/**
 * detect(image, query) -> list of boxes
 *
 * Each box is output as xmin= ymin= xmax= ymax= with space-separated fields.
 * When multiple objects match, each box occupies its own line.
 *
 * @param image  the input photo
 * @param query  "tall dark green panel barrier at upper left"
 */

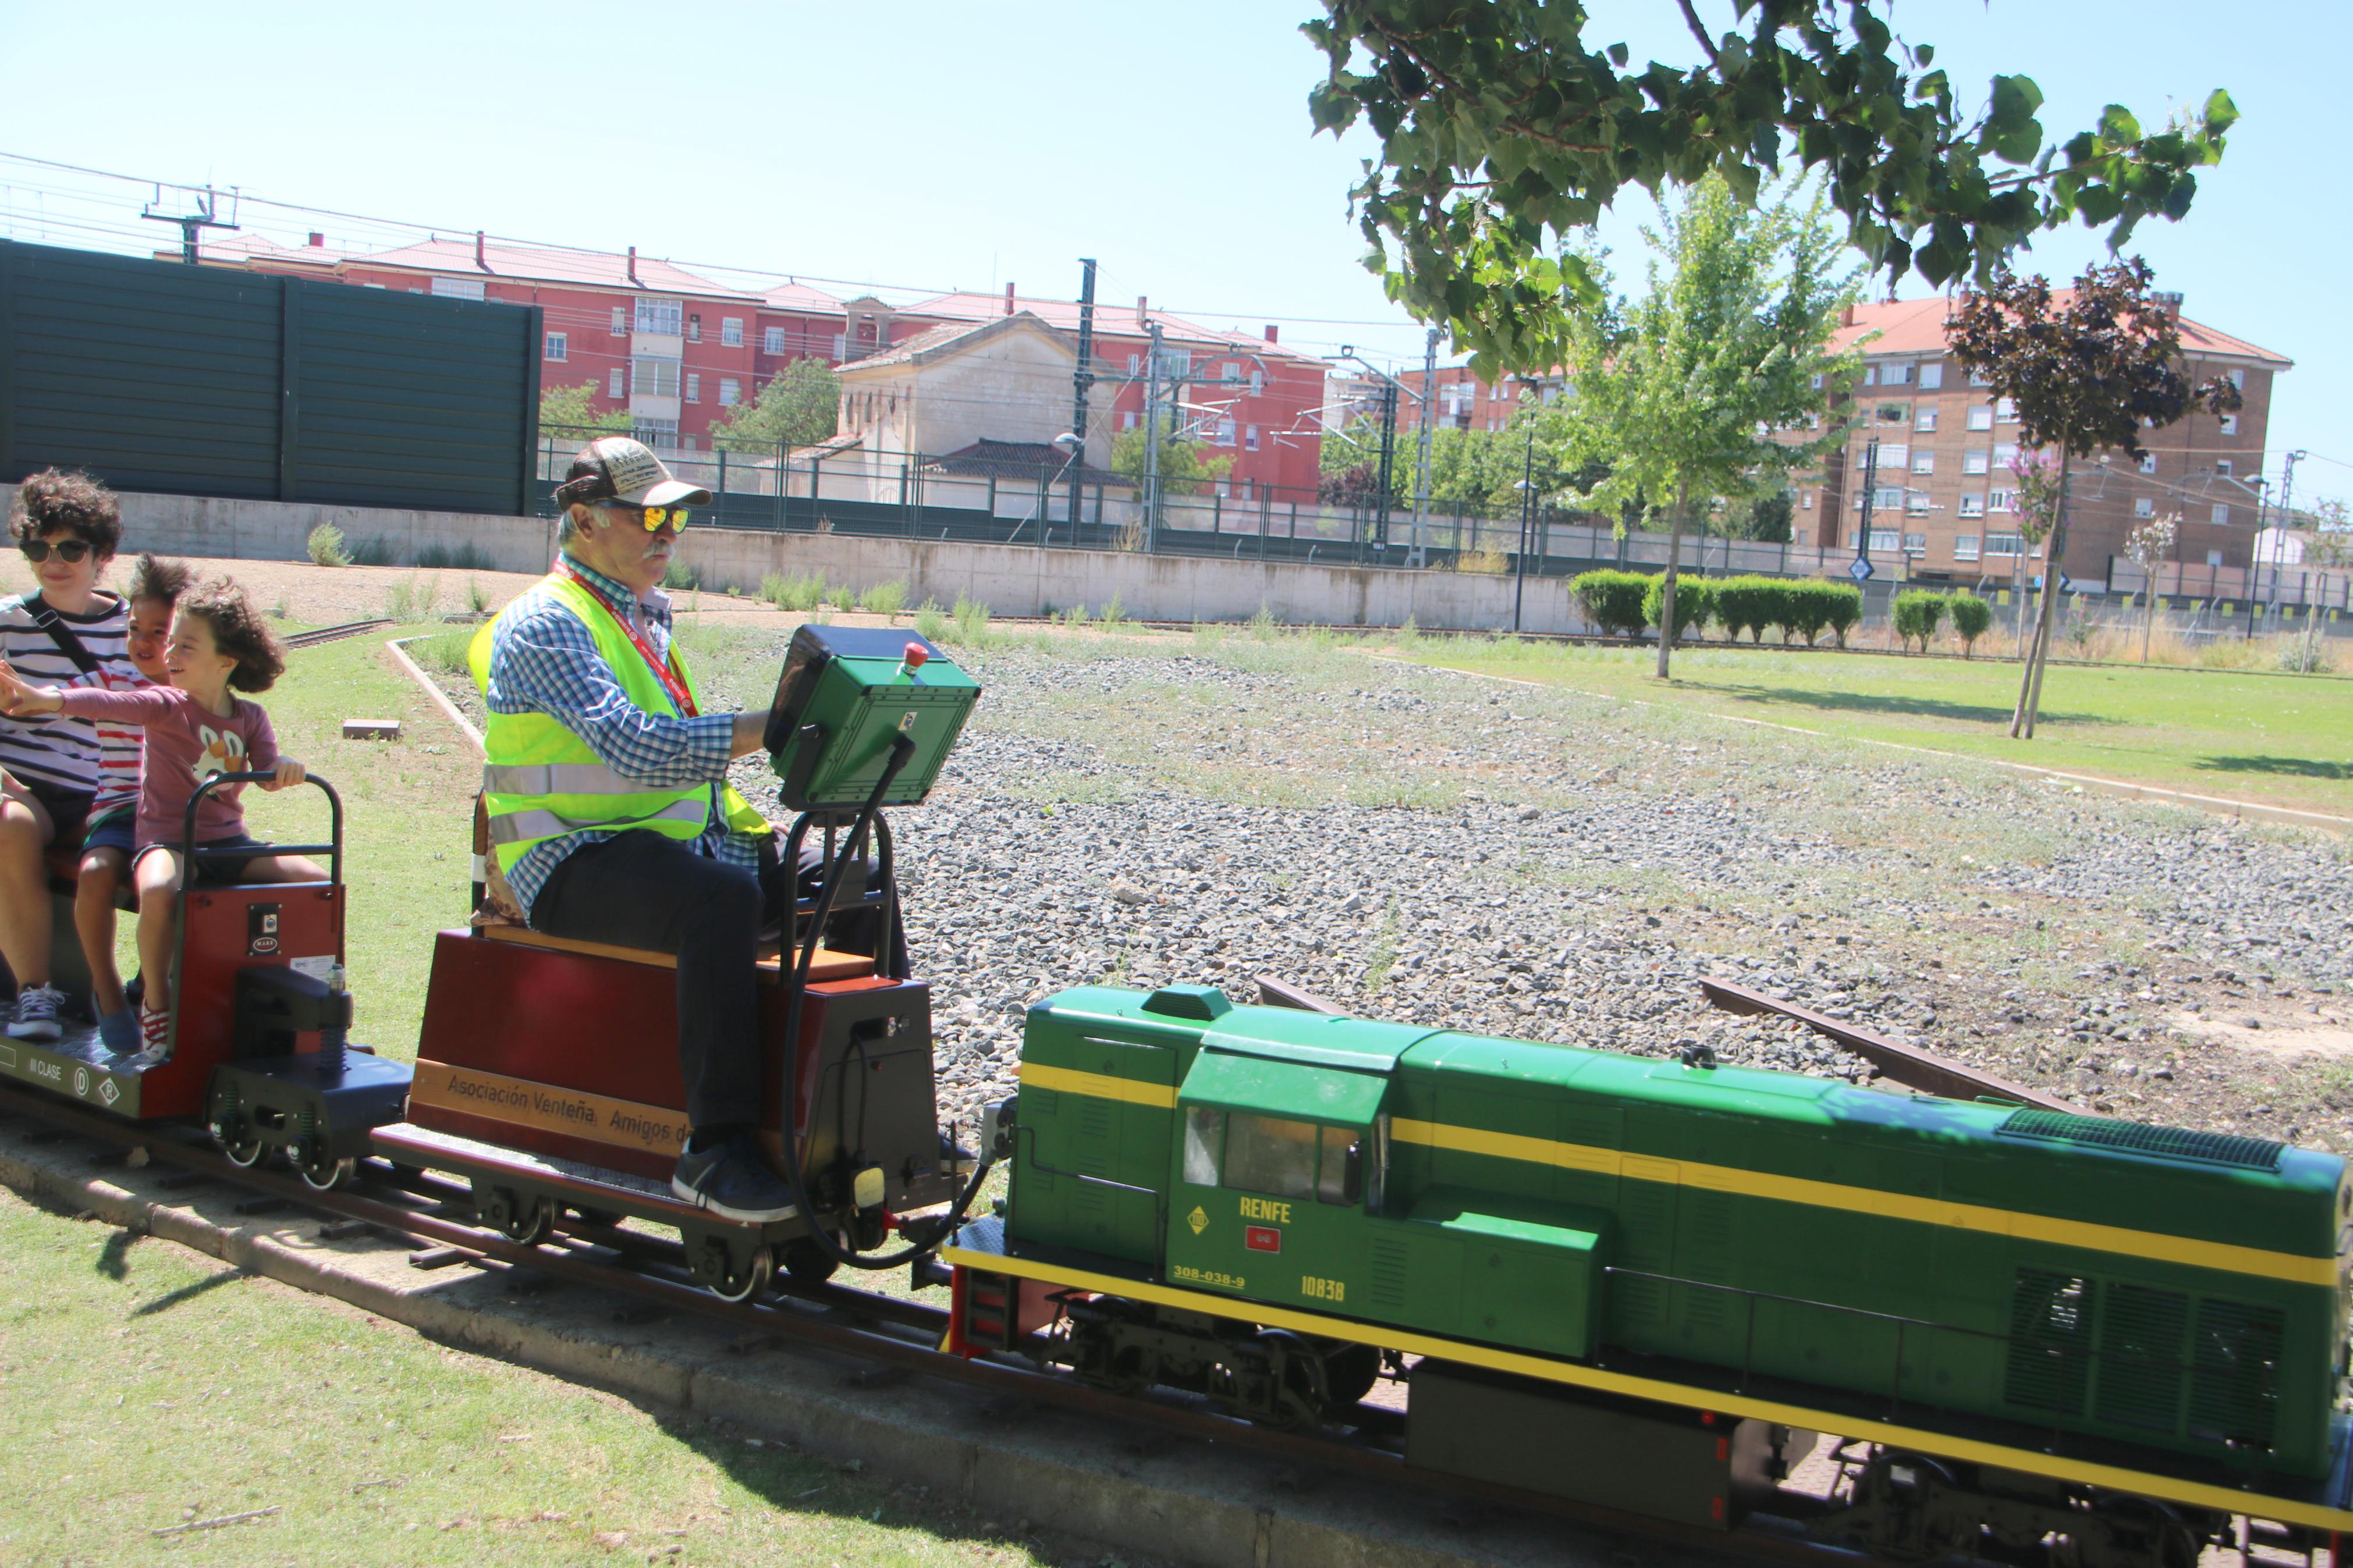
xmin=0 ymin=240 xmax=539 ymax=515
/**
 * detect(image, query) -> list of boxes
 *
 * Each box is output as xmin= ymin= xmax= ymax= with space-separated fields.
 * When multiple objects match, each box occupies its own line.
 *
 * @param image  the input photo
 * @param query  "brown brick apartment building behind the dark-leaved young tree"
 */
xmin=1791 ymin=296 xmax=2292 ymax=583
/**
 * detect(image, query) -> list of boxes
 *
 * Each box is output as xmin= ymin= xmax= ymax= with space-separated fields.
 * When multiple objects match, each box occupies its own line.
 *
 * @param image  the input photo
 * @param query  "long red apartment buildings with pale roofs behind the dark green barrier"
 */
xmin=174 ymin=235 xmax=1325 ymax=496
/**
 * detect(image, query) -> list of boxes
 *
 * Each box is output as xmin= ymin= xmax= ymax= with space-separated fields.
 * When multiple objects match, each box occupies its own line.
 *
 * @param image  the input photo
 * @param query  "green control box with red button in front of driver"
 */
xmin=765 ymin=625 xmax=981 ymax=811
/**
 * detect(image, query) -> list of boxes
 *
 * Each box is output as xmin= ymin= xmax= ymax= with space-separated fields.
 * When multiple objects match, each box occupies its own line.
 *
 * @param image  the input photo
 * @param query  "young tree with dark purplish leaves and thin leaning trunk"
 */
xmin=1946 ymin=256 xmax=2242 ymax=741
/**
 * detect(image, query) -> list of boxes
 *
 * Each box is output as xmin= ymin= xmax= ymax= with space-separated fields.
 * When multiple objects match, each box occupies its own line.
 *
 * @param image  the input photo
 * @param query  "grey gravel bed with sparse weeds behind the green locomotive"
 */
xmin=432 ymin=632 xmax=2353 ymax=1147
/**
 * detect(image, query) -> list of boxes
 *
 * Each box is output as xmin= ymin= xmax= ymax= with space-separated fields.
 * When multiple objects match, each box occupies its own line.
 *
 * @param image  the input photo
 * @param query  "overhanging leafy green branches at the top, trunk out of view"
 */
xmin=1301 ymin=0 xmax=2238 ymax=381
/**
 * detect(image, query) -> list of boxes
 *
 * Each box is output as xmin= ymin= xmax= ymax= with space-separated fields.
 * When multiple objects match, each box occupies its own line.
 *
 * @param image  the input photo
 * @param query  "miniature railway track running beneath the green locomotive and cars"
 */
xmin=0 ymin=1086 xmax=1871 ymax=1563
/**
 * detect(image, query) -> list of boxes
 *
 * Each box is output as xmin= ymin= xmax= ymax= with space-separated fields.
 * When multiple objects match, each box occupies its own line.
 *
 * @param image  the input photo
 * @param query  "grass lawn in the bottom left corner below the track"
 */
xmin=0 ymin=1192 xmax=1045 ymax=1568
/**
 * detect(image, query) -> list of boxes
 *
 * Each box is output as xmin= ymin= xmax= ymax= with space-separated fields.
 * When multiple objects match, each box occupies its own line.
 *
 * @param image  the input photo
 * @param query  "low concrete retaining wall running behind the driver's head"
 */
xmin=7 ymin=486 xmax=1591 ymax=632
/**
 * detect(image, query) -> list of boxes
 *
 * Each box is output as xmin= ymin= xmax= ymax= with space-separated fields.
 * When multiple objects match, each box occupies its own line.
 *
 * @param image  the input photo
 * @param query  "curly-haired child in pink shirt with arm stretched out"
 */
xmin=0 ymin=578 xmax=327 ymax=1065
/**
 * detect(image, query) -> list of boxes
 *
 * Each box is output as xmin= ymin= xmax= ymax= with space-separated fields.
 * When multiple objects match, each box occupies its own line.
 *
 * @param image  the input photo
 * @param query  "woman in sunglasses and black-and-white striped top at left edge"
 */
xmin=0 ymin=468 xmax=132 ymax=1041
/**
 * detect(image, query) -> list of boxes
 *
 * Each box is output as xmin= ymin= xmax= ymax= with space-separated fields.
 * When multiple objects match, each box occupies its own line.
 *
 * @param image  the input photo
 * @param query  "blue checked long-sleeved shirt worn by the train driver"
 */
xmin=482 ymin=557 xmax=760 ymax=919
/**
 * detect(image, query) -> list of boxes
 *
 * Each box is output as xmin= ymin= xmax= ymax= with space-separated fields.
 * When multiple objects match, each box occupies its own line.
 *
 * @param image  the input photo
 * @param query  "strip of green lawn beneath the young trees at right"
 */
xmin=1407 ymin=637 xmax=2353 ymax=816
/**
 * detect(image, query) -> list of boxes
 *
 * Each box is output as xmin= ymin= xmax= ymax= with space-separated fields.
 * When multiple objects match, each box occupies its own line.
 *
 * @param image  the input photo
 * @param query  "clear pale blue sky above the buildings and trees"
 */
xmin=0 ymin=0 xmax=2353 ymax=510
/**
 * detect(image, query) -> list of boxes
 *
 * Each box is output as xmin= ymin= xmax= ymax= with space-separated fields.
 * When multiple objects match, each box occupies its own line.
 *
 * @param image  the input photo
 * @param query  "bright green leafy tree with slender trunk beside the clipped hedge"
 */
xmin=1565 ymin=174 xmax=1861 ymax=680
